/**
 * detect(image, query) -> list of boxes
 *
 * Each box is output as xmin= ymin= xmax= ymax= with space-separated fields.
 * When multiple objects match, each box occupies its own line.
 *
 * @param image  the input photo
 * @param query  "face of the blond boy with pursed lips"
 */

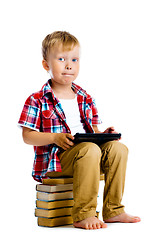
xmin=44 ymin=43 xmax=79 ymax=85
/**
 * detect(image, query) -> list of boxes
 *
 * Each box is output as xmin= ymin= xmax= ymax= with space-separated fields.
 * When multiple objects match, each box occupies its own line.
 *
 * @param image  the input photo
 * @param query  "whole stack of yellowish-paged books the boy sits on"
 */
xmin=35 ymin=178 xmax=73 ymax=227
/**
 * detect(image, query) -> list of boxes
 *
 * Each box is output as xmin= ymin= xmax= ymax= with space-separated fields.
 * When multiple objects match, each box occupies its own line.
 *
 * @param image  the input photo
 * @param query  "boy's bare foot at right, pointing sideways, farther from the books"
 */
xmin=104 ymin=213 xmax=141 ymax=223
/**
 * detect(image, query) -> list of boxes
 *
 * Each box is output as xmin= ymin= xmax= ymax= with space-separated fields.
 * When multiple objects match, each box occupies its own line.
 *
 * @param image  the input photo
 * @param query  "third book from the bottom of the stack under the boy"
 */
xmin=36 ymin=199 xmax=74 ymax=209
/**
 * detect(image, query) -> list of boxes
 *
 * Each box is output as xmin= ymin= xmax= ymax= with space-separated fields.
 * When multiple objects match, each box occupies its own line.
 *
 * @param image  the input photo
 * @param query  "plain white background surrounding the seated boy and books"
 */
xmin=0 ymin=0 xmax=160 ymax=239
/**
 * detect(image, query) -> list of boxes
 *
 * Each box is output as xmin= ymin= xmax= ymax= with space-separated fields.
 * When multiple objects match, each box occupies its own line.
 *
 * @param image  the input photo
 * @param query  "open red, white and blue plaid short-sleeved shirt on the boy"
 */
xmin=18 ymin=80 xmax=101 ymax=182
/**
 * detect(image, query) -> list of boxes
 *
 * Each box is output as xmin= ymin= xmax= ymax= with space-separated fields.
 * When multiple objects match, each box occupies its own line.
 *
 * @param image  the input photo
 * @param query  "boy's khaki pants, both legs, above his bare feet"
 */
xmin=47 ymin=141 xmax=128 ymax=222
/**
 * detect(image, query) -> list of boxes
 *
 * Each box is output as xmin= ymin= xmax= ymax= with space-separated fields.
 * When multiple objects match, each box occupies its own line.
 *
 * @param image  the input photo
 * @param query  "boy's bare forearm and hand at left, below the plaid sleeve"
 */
xmin=22 ymin=127 xmax=74 ymax=150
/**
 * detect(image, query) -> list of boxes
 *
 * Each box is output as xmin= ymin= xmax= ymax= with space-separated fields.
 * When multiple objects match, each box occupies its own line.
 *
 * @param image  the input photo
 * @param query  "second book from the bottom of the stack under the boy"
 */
xmin=35 ymin=207 xmax=72 ymax=218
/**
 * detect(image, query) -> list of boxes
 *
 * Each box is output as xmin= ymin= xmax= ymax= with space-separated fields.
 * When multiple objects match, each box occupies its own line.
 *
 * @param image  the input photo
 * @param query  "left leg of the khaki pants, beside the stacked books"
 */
xmin=47 ymin=142 xmax=101 ymax=222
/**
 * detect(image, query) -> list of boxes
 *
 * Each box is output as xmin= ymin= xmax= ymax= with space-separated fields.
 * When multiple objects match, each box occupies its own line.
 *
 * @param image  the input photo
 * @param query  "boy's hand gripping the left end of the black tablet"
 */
xmin=54 ymin=133 xmax=74 ymax=150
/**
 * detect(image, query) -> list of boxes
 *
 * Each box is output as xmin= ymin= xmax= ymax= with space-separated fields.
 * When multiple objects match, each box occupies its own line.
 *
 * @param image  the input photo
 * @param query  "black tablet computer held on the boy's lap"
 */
xmin=73 ymin=133 xmax=121 ymax=144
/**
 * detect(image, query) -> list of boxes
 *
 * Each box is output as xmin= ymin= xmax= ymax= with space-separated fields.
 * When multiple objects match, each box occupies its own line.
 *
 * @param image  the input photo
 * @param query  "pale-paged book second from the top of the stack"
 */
xmin=36 ymin=184 xmax=73 ymax=192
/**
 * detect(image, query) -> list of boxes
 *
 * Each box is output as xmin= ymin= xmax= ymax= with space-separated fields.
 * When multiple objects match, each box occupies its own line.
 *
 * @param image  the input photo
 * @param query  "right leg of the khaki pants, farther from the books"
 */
xmin=100 ymin=141 xmax=128 ymax=220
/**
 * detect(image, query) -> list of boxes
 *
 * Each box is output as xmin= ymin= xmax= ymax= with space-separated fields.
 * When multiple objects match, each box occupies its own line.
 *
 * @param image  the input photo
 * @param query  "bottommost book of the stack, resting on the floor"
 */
xmin=38 ymin=216 xmax=73 ymax=227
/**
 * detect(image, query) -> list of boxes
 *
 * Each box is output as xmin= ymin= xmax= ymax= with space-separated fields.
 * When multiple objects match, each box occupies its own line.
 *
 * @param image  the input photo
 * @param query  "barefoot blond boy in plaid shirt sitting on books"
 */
xmin=19 ymin=31 xmax=140 ymax=229
